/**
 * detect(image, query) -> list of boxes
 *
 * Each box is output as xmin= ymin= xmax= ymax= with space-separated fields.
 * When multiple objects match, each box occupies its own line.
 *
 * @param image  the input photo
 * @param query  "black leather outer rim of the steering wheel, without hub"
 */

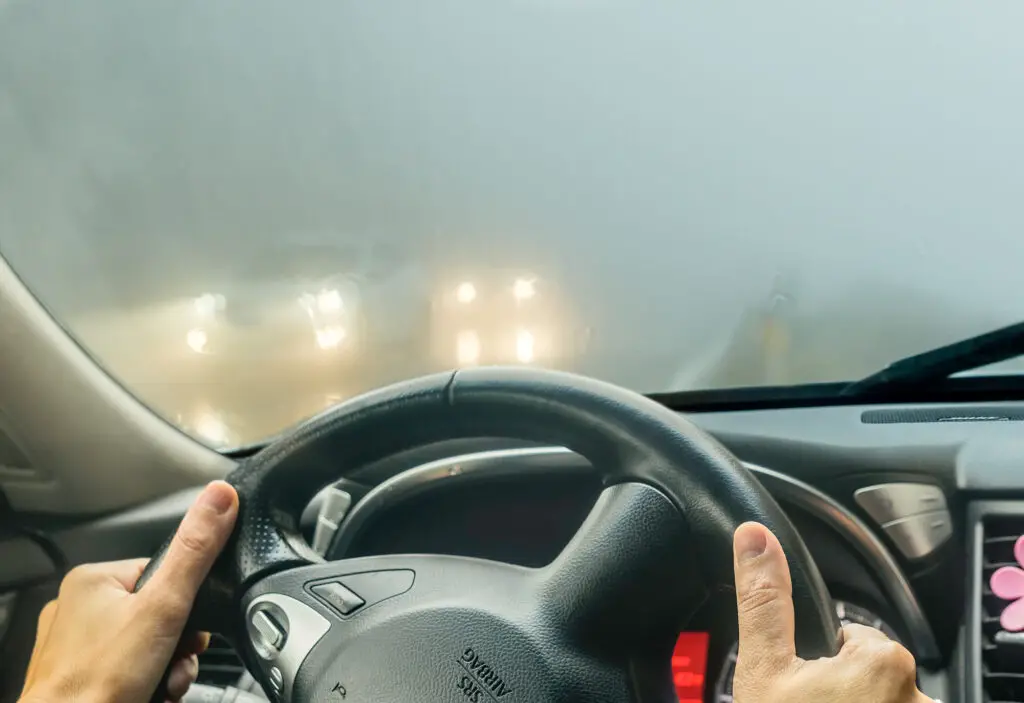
xmin=138 ymin=368 xmax=839 ymax=657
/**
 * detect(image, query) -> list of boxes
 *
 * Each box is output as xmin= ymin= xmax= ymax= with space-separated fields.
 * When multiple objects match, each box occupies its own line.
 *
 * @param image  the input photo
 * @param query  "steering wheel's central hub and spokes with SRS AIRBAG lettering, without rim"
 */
xmin=243 ymin=483 xmax=695 ymax=701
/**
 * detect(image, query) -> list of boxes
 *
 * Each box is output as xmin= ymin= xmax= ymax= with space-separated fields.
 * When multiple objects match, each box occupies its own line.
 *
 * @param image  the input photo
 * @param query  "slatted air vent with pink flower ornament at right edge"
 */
xmin=981 ymin=517 xmax=1024 ymax=703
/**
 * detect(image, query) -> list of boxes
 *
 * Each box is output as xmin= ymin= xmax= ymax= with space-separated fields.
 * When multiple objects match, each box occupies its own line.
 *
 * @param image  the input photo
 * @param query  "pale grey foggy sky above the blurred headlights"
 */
xmin=0 ymin=0 xmax=1024 ymax=374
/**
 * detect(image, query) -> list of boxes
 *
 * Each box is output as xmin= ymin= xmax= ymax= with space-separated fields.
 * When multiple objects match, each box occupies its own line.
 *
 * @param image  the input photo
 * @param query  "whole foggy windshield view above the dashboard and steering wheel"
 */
xmin=0 ymin=0 xmax=1024 ymax=446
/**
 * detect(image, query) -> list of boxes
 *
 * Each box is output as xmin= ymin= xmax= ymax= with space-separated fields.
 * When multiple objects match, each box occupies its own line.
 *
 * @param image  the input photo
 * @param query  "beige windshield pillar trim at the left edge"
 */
xmin=0 ymin=256 xmax=233 ymax=514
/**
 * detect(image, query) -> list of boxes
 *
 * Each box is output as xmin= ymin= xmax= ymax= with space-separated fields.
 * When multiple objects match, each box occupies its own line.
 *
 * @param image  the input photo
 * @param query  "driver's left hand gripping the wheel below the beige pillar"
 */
xmin=19 ymin=481 xmax=239 ymax=703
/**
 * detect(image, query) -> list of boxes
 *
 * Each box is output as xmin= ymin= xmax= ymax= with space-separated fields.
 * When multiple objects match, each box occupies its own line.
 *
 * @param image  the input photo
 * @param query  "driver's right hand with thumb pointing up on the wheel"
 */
xmin=732 ymin=523 xmax=933 ymax=703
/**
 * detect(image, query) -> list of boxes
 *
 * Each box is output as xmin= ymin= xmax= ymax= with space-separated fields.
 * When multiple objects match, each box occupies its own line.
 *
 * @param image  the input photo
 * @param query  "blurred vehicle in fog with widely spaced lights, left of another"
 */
xmin=184 ymin=235 xmax=430 ymax=374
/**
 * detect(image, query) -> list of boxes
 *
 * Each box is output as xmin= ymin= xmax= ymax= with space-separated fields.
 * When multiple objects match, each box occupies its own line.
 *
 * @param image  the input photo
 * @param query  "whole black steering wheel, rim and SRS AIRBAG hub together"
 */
xmin=137 ymin=368 xmax=840 ymax=703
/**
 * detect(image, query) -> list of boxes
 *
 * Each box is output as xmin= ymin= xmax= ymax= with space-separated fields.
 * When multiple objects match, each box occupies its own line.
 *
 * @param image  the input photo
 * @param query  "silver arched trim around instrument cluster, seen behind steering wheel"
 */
xmin=329 ymin=446 xmax=940 ymax=663
